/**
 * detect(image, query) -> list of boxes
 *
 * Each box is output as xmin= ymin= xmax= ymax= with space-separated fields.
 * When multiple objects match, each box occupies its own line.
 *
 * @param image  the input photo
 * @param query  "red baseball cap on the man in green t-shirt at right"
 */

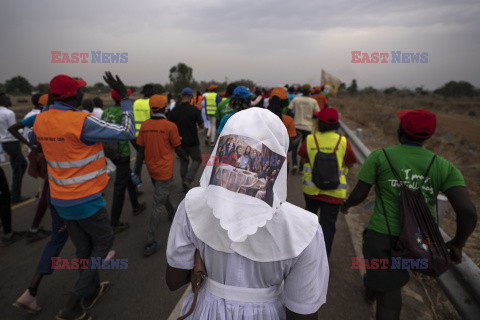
xmin=397 ymin=109 xmax=437 ymax=138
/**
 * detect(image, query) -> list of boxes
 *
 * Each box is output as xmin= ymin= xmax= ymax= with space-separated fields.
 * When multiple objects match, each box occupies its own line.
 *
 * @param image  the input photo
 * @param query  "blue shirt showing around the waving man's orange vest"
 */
xmin=30 ymin=100 xmax=135 ymax=220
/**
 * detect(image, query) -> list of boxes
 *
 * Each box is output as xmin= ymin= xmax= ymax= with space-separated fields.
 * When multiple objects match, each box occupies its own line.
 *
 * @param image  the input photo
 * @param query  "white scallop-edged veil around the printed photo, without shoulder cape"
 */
xmin=200 ymin=108 xmax=289 ymax=242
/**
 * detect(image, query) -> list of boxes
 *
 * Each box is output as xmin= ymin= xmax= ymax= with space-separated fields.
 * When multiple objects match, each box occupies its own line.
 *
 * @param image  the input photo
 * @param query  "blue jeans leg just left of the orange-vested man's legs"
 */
xmin=36 ymin=187 xmax=68 ymax=274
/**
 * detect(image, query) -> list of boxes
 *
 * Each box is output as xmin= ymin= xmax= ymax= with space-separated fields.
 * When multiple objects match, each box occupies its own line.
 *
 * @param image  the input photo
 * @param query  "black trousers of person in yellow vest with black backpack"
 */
xmin=303 ymin=194 xmax=341 ymax=257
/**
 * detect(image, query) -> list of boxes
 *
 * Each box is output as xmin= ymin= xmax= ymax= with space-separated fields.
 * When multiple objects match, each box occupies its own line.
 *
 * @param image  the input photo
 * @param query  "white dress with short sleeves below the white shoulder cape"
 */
xmin=167 ymin=200 xmax=329 ymax=320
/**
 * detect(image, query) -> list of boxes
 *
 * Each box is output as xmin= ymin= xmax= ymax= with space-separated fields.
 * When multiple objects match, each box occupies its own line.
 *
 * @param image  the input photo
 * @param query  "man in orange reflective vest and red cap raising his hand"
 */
xmin=31 ymin=72 xmax=135 ymax=320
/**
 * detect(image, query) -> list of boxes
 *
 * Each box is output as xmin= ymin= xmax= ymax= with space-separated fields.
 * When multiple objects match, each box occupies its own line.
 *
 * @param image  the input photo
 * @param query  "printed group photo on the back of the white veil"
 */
xmin=210 ymin=134 xmax=285 ymax=206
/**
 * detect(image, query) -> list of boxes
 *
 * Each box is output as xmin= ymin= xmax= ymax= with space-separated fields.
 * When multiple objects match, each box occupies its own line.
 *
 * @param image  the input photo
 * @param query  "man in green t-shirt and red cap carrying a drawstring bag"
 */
xmin=341 ymin=110 xmax=477 ymax=319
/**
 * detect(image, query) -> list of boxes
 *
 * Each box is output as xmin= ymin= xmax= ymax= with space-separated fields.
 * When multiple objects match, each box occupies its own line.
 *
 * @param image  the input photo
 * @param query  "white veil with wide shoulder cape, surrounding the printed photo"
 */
xmin=185 ymin=108 xmax=319 ymax=262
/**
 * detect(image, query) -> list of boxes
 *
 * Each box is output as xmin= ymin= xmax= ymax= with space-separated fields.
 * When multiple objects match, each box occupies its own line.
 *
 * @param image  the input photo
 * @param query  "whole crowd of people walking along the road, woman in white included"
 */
xmin=0 ymin=72 xmax=476 ymax=320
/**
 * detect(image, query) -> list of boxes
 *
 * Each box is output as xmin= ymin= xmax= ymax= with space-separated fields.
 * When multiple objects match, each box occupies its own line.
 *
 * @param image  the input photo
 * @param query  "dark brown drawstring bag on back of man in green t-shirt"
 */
xmin=377 ymin=149 xmax=451 ymax=277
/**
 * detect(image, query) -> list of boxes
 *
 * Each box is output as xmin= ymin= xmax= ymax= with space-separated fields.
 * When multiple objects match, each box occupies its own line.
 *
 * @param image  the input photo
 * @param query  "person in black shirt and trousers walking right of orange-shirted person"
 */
xmin=168 ymin=88 xmax=203 ymax=192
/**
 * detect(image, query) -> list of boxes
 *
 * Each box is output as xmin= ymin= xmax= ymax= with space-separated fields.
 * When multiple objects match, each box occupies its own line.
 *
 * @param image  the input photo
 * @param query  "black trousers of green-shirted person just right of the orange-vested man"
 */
xmin=111 ymin=157 xmax=140 ymax=226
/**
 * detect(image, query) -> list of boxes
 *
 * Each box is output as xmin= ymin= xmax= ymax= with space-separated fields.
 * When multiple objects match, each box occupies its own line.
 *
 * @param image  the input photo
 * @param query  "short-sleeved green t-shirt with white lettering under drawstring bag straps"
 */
xmin=357 ymin=145 xmax=465 ymax=236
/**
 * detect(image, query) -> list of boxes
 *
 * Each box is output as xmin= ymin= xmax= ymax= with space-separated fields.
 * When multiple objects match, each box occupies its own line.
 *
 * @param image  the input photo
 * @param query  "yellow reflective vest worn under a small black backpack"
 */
xmin=302 ymin=131 xmax=348 ymax=199
